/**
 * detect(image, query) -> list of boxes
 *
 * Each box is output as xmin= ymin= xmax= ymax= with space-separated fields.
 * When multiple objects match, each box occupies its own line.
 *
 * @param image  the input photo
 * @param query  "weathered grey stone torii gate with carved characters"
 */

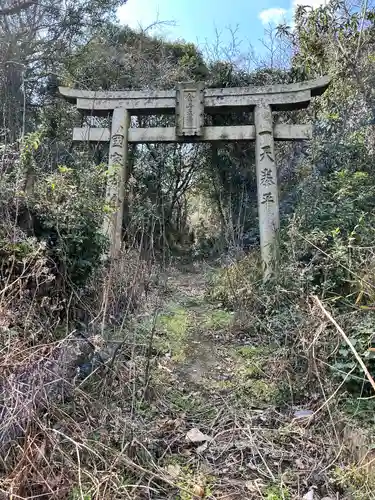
xmin=59 ymin=77 xmax=329 ymax=279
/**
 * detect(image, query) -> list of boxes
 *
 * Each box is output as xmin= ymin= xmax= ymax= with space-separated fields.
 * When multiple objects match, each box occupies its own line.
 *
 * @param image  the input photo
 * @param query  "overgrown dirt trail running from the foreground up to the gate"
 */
xmin=132 ymin=266 xmax=338 ymax=500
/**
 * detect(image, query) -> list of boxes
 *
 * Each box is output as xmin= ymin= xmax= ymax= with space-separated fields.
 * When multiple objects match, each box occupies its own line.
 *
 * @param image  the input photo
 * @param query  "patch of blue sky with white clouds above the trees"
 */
xmin=118 ymin=0 xmax=324 ymax=56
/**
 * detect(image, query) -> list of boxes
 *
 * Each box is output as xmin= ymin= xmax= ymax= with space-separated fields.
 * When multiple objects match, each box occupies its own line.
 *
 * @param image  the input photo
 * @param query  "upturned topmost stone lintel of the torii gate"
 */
xmin=59 ymin=76 xmax=330 ymax=115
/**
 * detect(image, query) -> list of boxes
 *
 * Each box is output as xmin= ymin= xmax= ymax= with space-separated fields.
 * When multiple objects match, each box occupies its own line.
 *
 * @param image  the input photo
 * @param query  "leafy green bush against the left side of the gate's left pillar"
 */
xmin=29 ymin=165 xmax=105 ymax=285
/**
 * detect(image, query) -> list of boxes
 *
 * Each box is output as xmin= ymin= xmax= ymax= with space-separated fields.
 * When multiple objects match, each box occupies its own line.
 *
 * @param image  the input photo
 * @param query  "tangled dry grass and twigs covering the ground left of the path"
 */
xmin=0 ymin=238 xmax=162 ymax=498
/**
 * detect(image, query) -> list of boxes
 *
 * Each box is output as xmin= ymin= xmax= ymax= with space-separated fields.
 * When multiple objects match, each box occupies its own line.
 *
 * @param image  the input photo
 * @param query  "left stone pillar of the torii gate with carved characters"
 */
xmin=103 ymin=108 xmax=130 ymax=259
